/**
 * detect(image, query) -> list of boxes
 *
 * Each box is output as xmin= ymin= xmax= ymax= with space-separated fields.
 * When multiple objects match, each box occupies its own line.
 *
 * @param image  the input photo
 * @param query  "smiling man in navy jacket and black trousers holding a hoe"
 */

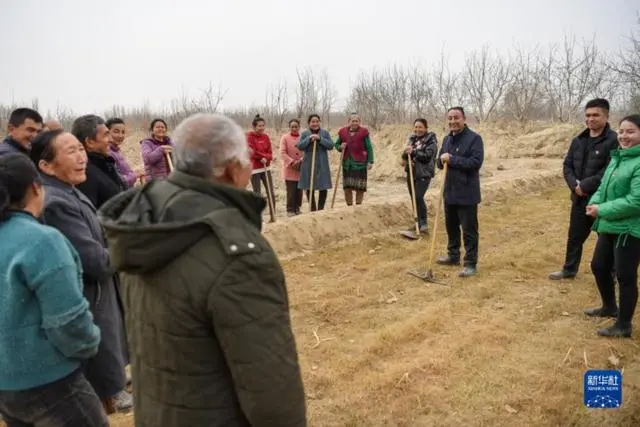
xmin=436 ymin=107 xmax=484 ymax=277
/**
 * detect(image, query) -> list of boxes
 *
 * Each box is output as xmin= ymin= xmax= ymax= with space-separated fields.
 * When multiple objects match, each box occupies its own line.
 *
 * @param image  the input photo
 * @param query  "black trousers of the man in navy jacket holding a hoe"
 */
xmin=444 ymin=203 xmax=479 ymax=267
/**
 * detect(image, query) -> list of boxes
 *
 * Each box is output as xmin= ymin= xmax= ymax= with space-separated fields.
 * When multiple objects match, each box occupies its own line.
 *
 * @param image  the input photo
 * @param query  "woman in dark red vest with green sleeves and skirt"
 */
xmin=336 ymin=114 xmax=373 ymax=206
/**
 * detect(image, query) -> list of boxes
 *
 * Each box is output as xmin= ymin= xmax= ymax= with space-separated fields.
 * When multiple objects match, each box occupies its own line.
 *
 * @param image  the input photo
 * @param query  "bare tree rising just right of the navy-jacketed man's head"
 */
xmin=462 ymin=45 xmax=511 ymax=121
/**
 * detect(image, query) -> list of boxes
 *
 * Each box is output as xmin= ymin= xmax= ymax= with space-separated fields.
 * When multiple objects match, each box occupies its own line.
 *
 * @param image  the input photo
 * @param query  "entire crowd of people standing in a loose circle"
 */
xmin=0 ymin=99 xmax=640 ymax=427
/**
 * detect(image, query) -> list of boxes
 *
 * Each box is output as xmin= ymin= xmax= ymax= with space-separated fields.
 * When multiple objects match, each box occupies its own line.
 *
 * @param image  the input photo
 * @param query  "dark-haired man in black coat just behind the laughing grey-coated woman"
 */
xmin=71 ymin=114 xmax=126 ymax=209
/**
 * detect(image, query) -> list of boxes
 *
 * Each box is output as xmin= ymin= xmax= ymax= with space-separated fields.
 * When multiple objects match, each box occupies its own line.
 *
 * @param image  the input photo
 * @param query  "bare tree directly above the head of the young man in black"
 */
xmin=543 ymin=35 xmax=613 ymax=122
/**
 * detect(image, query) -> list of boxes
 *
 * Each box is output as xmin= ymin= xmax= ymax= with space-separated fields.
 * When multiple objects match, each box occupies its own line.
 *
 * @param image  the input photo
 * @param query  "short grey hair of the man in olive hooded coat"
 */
xmin=171 ymin=113 xmax=250 ymax=179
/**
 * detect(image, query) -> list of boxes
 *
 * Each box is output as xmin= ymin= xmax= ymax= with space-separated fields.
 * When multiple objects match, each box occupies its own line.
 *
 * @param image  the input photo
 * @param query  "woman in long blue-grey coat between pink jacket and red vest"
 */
xmin=297 ymin=114 xmax=334 ymax=211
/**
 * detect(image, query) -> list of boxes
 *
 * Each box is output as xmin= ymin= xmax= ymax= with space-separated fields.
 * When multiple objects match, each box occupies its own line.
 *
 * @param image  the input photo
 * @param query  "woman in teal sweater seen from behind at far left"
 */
xmin=0 ymin=153 xmax=109 ymax=427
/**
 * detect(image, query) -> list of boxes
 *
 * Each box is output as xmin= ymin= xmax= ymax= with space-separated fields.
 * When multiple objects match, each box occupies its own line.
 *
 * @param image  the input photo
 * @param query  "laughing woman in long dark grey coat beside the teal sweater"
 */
xmin=31 ymin=130 xmax=127 ymax=413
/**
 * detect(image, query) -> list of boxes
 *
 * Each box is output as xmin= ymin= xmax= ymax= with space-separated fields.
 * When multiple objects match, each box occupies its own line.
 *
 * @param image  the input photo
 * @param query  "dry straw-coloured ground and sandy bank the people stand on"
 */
xmin=6 ymin=125 xmax=640 ymax=427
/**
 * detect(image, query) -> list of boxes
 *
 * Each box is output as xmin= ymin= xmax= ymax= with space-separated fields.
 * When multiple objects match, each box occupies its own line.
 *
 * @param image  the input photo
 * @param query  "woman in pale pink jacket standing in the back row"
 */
xmin=280 ymin=119 xmax=302 ymax=216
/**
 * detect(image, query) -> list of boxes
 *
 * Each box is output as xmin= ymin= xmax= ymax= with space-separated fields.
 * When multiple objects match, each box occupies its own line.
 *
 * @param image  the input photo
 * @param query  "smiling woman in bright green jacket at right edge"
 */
xmin=584 ymin=114 xmax=640 ymax=338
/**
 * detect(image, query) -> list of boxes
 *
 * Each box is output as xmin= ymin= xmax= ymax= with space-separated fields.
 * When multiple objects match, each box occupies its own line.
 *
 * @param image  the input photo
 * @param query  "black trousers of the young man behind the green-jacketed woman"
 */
xmin=562 ymin=197 xmax=594 ymax=275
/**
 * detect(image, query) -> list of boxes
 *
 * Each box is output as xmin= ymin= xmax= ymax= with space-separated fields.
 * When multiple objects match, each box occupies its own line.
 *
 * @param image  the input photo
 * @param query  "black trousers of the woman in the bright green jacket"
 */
xmin=591 ymin=234 xmax=640 ymax=326
